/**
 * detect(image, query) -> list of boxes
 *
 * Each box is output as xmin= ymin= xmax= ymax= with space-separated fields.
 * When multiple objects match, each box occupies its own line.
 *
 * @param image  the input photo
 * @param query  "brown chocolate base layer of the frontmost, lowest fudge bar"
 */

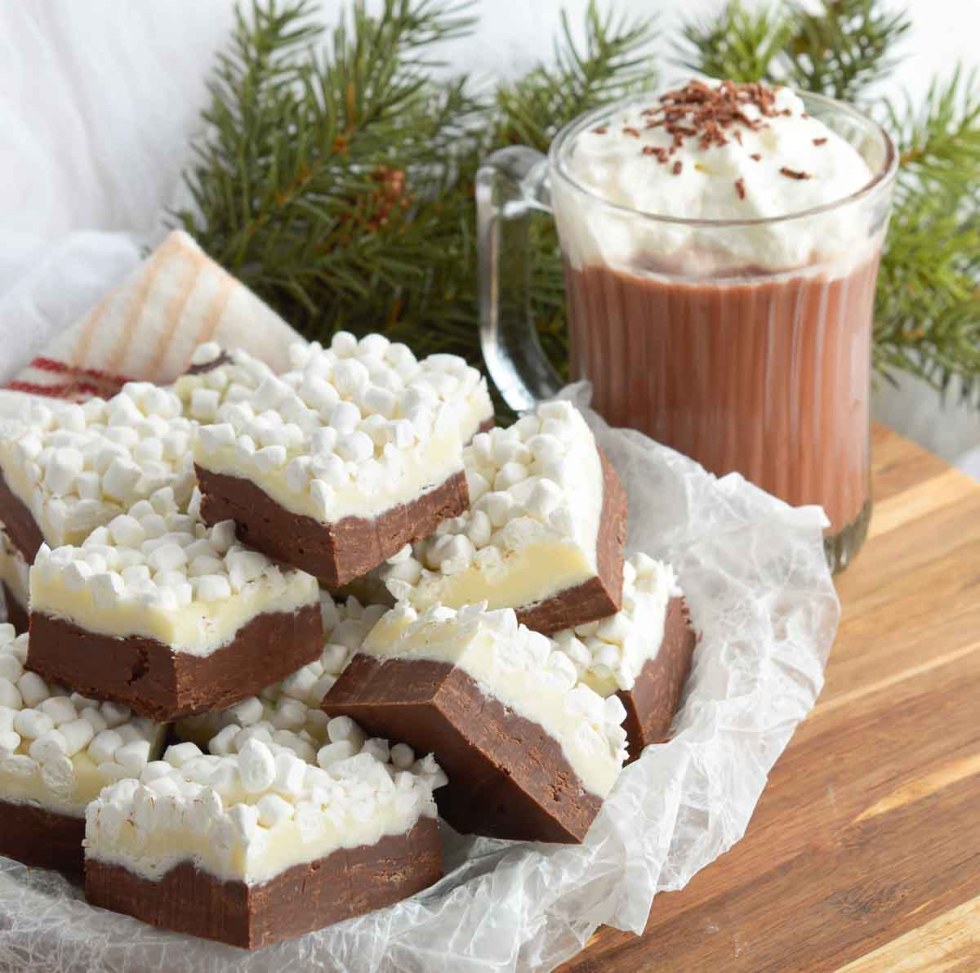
xmin=85 ymin=818 xmax=442 ymax=949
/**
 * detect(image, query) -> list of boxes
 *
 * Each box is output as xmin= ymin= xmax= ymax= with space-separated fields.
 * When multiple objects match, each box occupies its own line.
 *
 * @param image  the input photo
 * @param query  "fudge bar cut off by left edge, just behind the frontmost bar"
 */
xmin=0 ymin=625 xmax=164 ymax=872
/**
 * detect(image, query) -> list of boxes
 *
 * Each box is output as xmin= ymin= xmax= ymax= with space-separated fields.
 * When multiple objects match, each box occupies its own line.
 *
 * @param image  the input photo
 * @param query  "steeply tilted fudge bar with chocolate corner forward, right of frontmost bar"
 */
xmin=323 ymin=604 xmax=626 ymax=842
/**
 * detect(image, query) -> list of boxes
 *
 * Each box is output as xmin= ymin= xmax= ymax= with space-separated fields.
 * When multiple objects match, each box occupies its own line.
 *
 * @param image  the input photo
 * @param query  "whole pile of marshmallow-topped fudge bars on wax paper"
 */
xmin=0 ymin=333 xmax=695 ymax=948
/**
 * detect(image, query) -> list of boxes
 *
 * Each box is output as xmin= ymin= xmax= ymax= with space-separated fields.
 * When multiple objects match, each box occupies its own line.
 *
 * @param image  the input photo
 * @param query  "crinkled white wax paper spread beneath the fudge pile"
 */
xmin=0 ymin=387 xmax=839 ymax=973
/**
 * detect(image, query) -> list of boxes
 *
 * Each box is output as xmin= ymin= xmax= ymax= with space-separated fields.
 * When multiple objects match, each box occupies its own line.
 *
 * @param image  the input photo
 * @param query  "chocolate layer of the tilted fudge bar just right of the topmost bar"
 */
xmin=517 ymin=450 xmax=628 ymax=635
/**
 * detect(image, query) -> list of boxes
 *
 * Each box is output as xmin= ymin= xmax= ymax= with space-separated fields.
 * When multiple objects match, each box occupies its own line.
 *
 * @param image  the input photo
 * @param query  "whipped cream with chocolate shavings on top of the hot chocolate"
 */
xmin=553 ymin=75 xmax=884 ymax=274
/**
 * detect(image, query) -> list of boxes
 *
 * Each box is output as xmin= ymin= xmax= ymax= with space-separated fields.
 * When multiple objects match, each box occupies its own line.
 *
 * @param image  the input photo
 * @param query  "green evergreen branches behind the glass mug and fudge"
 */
xmin=178 ymin=0 xmax=980 ymax=402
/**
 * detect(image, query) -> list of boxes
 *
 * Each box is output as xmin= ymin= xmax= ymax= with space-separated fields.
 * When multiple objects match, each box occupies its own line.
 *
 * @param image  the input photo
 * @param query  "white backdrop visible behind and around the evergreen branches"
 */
xmin=0 ymin=0 xmax=980 ymax=475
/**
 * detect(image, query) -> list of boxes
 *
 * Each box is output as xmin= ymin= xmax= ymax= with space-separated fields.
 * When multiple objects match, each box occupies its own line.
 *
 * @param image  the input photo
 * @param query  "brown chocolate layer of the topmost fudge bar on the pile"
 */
xmin=196 ymin=466 xmax=469 ymax=588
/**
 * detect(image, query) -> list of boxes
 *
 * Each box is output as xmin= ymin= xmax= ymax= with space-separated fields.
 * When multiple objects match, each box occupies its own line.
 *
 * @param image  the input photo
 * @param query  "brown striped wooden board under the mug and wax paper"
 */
xmin=562 ymin=428 xmax=980 ymax=973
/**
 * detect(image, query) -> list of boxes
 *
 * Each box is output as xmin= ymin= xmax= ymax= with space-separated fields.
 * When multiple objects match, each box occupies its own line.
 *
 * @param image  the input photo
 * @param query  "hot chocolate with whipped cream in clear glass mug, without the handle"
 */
xmin=551 ymin=82 xmax=891 ymax=566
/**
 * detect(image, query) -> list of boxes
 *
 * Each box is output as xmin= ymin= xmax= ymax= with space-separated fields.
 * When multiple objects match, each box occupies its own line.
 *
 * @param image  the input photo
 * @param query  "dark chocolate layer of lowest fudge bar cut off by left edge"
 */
xmin=0 ymin=801 xmax=85 ymax=874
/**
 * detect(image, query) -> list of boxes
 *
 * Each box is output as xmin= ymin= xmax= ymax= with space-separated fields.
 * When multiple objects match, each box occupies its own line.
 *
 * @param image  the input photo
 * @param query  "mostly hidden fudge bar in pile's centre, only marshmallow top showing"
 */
xmin=175 ymin=592 xmax=388 ymax=753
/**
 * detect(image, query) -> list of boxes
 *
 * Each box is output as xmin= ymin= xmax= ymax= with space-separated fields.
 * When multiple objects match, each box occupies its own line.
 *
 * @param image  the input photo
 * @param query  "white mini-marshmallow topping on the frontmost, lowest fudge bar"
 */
xmin=85 ymin=717 xmax=446 ymax=885
